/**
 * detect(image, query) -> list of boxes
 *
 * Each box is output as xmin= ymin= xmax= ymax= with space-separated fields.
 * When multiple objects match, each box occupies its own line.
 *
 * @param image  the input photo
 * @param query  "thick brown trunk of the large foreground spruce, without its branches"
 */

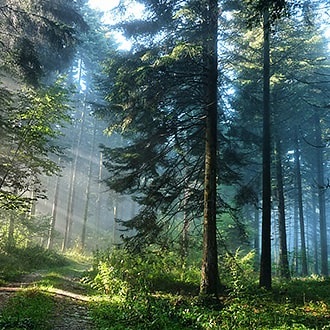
xmin=200 ymin=0 xmax=220 ymax=296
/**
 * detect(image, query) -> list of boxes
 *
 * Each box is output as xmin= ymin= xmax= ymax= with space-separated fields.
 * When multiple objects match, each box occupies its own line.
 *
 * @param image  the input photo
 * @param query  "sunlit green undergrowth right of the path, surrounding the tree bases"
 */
xmin=85 ymin=250 xmax=330 ymax=330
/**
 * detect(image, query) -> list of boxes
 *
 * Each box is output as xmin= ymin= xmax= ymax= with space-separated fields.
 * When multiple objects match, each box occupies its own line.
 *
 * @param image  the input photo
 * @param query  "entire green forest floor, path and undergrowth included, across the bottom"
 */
xmin=0 ymin=248 xmax=330 ymax=330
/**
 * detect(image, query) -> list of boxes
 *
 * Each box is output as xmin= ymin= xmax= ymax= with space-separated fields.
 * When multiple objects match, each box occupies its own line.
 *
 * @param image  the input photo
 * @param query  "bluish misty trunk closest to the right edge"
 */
xmin=314 ymin=112 xmax=329 ymax=276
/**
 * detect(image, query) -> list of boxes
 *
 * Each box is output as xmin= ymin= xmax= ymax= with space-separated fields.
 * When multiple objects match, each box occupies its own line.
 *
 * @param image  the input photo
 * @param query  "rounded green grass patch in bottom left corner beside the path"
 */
xmin=0 ymin=287 xmax=54 ymax=330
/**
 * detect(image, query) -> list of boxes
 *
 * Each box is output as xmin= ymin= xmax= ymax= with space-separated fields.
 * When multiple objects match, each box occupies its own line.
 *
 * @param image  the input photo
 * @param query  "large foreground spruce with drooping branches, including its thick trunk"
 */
xmin=96 ymin=1 xmax=241 ymax=295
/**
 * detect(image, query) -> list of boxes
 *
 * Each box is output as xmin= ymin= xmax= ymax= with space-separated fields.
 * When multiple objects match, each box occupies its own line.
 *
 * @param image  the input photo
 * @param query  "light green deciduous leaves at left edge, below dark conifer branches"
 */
xmin=0 ymin=80 xmax=69 ymax=209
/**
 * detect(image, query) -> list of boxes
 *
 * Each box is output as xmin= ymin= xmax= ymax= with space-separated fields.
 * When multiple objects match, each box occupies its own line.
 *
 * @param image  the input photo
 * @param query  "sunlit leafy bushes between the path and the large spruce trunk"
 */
xmin=85 ymin=249 xmax=199 ymax=297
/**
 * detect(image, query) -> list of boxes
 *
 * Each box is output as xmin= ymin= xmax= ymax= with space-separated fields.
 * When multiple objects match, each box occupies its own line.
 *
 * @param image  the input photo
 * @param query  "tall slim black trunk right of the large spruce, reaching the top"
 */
xmin=259 ymin=1 xmax=272 ymax=289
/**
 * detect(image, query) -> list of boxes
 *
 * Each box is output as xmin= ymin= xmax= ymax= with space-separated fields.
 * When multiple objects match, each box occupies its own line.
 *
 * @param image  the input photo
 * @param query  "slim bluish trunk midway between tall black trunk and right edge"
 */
xmin=294 ymin=129 xmax=308 ymax=276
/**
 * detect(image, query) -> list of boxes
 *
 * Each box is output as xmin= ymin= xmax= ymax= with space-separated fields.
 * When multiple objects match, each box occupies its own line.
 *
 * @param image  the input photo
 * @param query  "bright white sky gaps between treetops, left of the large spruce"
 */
xmin=88 ymin=0 xmax=144 ymax=50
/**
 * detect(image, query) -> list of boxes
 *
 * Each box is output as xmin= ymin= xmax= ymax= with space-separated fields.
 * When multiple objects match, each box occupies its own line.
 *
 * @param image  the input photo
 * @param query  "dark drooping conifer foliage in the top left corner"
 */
xmin=0 ymin=0 xmax=87 ymax=85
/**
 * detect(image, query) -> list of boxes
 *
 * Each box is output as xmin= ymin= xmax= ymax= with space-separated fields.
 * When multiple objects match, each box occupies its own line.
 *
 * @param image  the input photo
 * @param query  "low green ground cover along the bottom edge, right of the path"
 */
xmin=87 ymin=280 xmax=330 ymax=330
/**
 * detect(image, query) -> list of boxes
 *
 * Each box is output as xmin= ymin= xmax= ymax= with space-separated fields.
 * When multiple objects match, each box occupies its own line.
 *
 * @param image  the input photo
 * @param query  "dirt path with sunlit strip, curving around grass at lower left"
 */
xmin=0 ymin=273 xmax=96 ymax=330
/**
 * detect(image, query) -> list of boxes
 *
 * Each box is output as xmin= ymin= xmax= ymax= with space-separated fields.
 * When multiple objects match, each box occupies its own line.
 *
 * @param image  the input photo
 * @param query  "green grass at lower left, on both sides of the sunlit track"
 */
xmin=0 ymin=247 xmax=92 ymax=330
